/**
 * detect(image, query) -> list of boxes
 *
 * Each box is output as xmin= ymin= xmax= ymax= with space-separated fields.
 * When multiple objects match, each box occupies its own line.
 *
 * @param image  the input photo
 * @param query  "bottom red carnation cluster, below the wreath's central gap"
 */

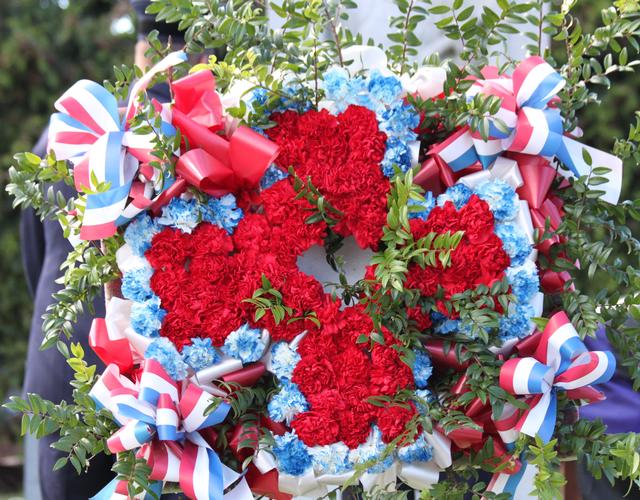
xmin=291 ymin=303 xmax=415 ymax=448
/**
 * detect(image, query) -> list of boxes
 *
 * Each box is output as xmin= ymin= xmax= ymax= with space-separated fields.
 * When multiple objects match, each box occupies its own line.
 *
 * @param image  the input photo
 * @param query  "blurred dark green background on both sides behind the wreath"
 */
xmin=0 ymin=0 xmax=640 ymax=489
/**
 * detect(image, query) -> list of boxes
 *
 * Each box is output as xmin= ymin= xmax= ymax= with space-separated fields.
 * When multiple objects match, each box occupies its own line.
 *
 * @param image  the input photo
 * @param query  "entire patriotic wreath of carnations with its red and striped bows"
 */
xmin=12 ymin=6 xmax=620 ymax=492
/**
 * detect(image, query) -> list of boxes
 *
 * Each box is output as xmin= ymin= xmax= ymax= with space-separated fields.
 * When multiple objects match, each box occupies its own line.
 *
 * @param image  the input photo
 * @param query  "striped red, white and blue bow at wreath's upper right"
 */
xmin=432 ymin=56 xmax=622 ymax=203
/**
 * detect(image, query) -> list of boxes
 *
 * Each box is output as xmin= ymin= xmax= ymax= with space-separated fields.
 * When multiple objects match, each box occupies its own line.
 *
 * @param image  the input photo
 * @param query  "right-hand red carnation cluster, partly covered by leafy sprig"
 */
xmin=406 ymin=195 xmax=510 ymax=312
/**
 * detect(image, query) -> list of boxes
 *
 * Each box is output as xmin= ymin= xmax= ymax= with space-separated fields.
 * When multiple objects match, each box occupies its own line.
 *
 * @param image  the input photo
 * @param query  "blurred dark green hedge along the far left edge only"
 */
xmin=0 ymin=0 xmax=133 ymax=440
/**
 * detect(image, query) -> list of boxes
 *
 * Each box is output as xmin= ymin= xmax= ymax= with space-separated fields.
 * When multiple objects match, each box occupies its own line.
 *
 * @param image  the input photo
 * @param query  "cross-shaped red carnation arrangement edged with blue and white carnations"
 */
xmin=102 ymin=63 xmax=539 ymax=492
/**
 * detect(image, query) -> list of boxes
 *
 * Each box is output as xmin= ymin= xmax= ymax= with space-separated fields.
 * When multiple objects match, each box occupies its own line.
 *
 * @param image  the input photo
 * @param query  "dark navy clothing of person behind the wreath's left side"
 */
xmin=20 ymin=132 xmax=114 ymax=500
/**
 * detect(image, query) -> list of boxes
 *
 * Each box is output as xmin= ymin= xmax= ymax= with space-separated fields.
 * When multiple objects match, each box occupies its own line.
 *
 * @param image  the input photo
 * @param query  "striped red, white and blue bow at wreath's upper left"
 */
xmin=49 ymin=51 xmax=186 ymax=240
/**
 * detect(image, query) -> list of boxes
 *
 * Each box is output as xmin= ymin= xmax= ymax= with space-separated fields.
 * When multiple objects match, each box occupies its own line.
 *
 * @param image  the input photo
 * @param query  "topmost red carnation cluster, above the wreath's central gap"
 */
xmin=267 ymin=106 xmax=390 ymax=249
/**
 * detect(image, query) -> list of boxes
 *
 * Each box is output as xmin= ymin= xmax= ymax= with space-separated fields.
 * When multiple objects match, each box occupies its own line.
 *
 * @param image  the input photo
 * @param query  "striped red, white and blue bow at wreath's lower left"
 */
xmin=90 ymin=359 xmax=248 ymax=500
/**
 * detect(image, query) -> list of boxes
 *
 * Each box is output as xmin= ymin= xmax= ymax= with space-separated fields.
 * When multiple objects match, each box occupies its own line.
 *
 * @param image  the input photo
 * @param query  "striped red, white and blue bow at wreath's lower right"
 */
xmin=500 ymin=312 xmax=616 ymax=442
